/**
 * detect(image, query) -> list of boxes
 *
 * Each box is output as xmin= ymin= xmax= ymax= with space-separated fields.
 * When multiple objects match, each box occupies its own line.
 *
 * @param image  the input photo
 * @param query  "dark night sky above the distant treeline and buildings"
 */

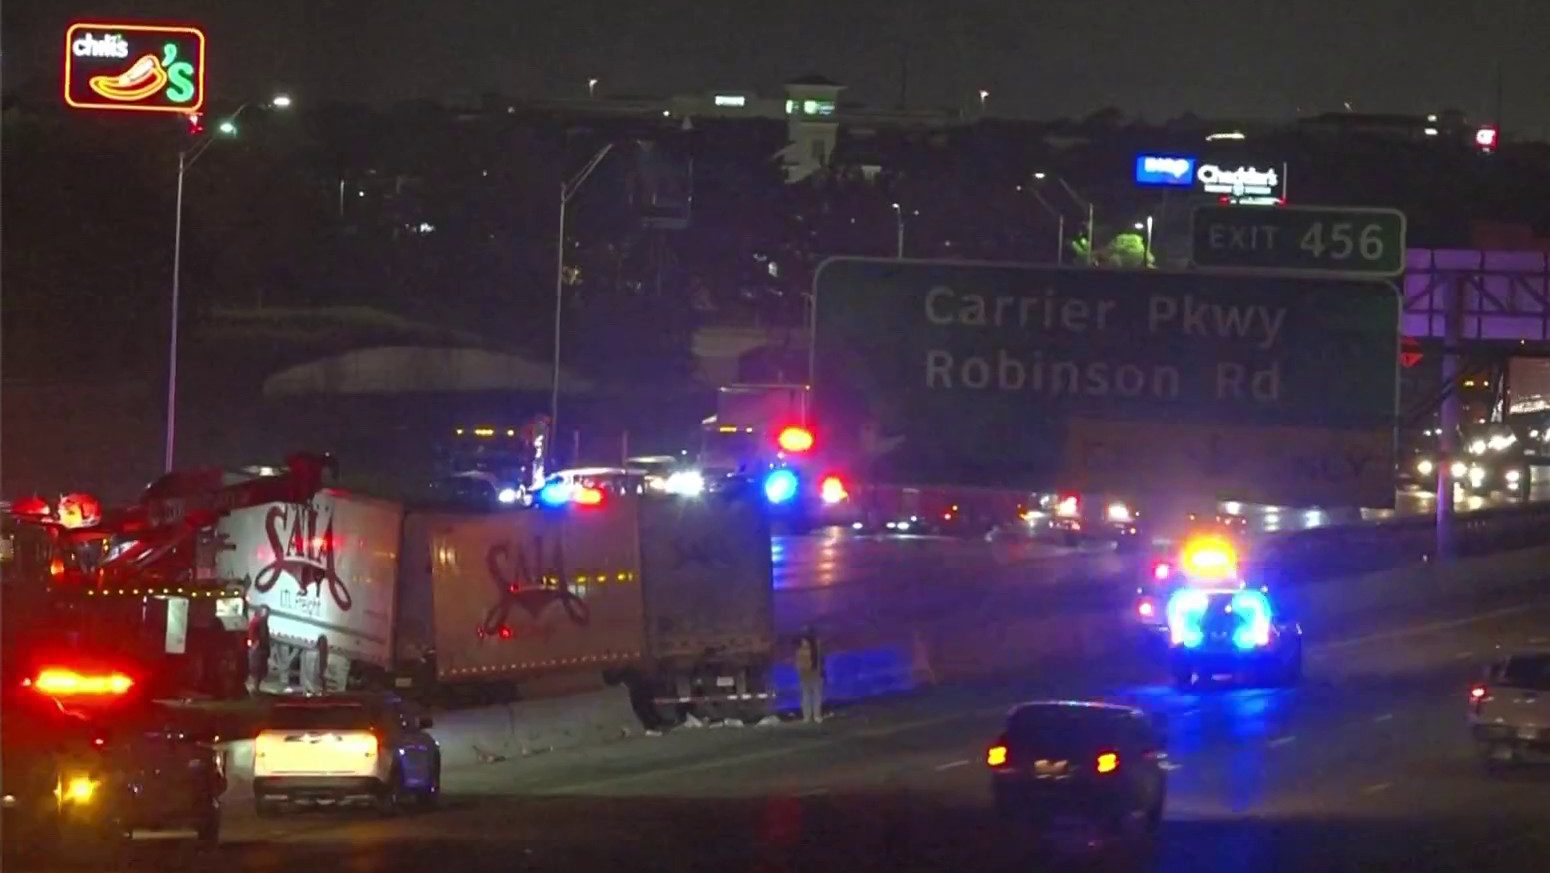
xmin=3 ymin=0 xmax=1550 ymax=138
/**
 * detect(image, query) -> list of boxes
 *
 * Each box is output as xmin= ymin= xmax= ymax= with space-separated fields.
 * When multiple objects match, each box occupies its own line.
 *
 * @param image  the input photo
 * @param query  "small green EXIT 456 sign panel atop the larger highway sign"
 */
xmin=1190 ymin=205 xmax=1404 ymax=276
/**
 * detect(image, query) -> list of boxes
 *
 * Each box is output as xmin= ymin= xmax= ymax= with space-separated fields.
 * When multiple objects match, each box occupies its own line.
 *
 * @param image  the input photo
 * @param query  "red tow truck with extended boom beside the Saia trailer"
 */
xmin=0 ymin=453 xmax=335 ymax=698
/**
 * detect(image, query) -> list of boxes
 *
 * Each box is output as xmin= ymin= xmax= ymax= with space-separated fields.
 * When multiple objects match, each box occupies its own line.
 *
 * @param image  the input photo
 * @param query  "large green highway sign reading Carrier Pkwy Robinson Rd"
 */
xmin=812 ymin=257 xmax=1400 ymax=506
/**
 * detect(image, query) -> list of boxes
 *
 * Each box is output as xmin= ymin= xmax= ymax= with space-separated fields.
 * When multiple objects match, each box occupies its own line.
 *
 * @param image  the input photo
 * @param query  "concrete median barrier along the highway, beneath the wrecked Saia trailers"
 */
xmin=212 ymin=546 xmax=1550 ymax=797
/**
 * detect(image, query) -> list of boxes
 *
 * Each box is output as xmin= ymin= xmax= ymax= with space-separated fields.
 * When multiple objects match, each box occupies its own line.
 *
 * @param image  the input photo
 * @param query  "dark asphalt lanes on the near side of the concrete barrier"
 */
xmin=69 ymin=602 xmax=1550 ymax=873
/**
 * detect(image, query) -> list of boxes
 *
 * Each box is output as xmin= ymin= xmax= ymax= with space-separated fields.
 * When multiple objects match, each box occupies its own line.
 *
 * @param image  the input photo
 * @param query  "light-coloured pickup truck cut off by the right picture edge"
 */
xmin=1469 ymin=651 xmax=1550 ymax=769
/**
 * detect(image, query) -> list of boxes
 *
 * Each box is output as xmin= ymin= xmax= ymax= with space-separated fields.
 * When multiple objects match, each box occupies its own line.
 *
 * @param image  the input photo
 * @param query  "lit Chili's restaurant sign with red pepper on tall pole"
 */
xmin=65 ymin=22 xmax=205 ymax=113
